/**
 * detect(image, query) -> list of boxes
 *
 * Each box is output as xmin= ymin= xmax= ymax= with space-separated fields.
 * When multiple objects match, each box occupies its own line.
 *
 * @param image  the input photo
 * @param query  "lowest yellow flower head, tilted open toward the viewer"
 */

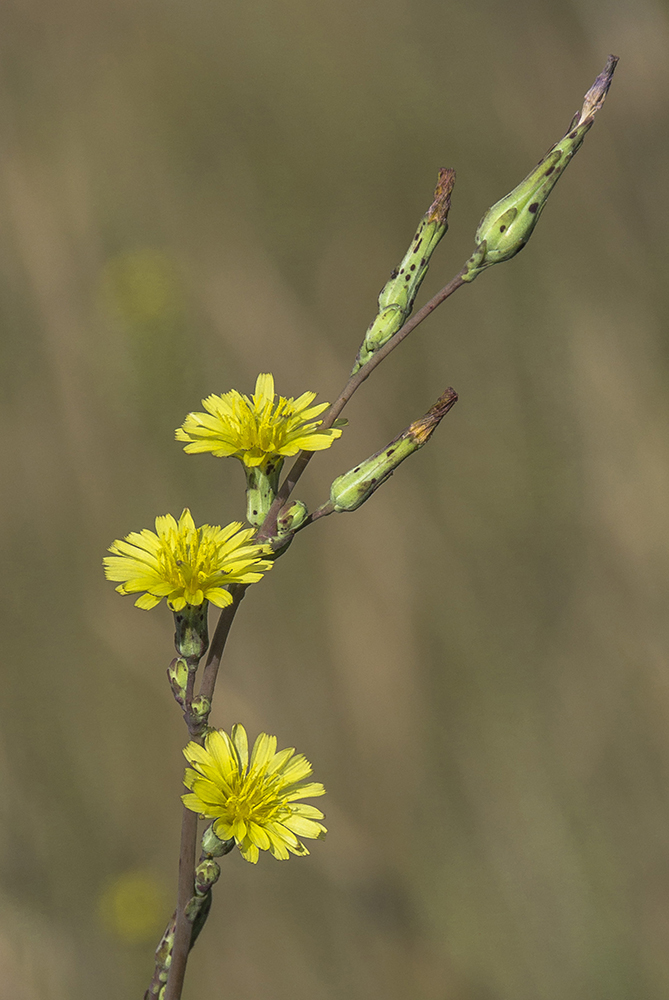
xmin=183 ymin=725 xmax=326 ymax=864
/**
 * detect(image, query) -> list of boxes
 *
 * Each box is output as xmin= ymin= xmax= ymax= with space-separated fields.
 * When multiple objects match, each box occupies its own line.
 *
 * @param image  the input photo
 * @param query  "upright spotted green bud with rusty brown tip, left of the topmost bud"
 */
xmin=351 ymin=169 xmax=455 ymax=375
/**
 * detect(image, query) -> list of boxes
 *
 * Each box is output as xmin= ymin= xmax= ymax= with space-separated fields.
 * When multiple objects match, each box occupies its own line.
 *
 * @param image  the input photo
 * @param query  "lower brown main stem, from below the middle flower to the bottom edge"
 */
xmin=165 ymin=584 xmax=246 ymax=1000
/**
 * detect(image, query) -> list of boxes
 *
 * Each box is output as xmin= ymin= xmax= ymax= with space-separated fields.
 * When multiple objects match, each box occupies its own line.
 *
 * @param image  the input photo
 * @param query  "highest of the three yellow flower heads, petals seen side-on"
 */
xmin=176 ymin=375 xmax=341 ymax=467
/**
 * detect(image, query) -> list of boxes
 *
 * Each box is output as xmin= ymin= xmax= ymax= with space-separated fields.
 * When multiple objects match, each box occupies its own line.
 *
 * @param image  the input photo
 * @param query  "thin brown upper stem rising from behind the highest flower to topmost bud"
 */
xmin=258 ymin=268 xmax=466 ymax=541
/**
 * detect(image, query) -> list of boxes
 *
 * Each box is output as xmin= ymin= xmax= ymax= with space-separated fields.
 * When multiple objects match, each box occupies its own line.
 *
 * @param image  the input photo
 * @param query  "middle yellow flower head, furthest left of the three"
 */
xmin=104 ymin=509 xmax=272 ymax=611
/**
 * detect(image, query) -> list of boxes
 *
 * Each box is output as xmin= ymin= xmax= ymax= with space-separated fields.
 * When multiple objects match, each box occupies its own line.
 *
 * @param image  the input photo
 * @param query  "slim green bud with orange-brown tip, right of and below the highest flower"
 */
xmin=330 ymin=389 xmax=458 ymax=513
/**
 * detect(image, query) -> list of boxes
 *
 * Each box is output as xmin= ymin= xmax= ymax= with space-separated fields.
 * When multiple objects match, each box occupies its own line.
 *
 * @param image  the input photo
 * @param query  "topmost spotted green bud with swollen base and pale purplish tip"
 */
xmin=463 ymin=56 xmax=618 ymax=281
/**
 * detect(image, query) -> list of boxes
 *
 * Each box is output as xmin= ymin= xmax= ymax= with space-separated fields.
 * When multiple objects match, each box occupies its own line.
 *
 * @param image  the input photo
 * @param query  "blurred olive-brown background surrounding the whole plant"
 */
xmin=0 ymin=0 xmax=669 ymax=1000
